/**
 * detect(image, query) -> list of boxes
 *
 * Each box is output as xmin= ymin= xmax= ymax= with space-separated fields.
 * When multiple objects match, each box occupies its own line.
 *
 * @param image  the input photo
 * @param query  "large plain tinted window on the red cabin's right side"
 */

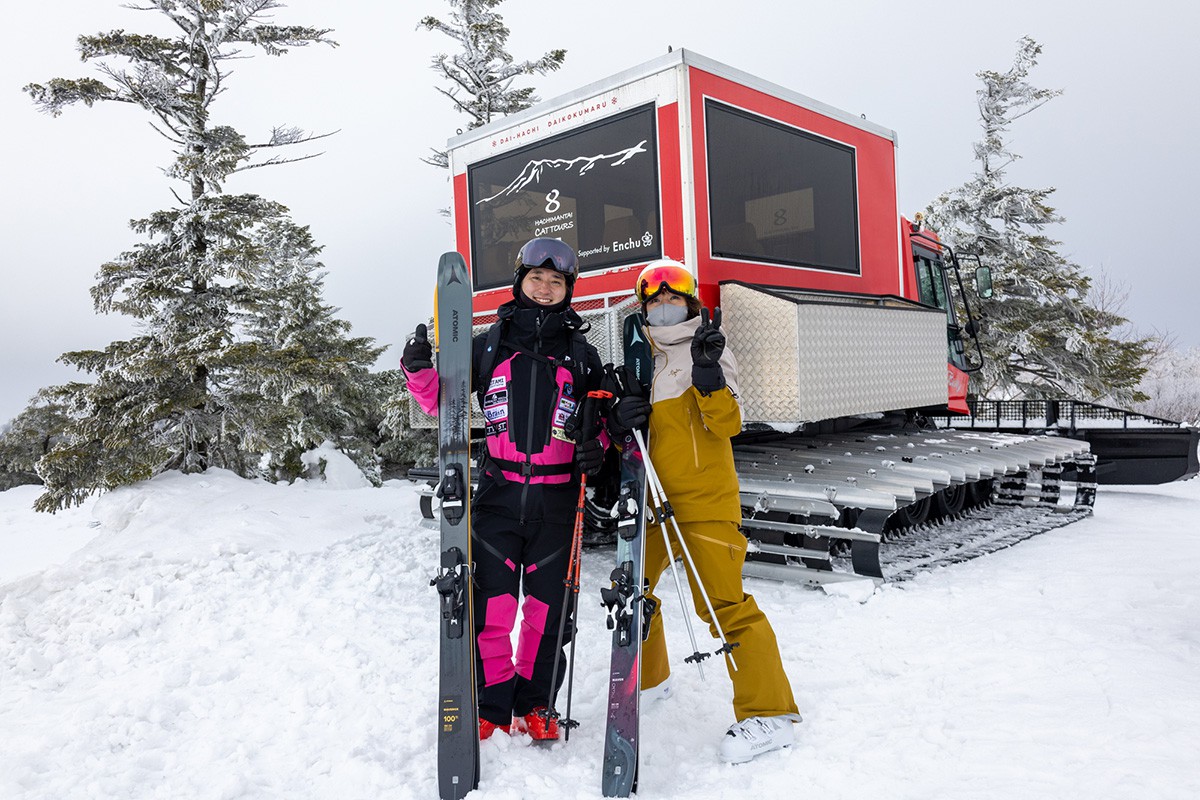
xmin=704 ymin=101 xmax=859 ymax=273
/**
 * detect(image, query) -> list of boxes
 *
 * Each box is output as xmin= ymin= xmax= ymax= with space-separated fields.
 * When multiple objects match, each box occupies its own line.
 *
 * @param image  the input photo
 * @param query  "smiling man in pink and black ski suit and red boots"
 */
xmin=401 ymin=239 xmax=607 ymax=739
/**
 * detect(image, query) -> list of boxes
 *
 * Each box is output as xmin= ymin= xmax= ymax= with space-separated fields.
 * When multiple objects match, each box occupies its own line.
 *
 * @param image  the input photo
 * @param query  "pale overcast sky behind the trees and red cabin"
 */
xmin=0 ymin=0 xmax=1200 ymax=422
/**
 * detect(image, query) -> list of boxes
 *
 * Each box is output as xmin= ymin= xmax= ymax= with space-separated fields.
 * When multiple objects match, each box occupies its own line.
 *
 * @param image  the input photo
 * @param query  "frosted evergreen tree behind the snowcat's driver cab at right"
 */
xmin=926 ymin=37 xmax=1153 ymax=404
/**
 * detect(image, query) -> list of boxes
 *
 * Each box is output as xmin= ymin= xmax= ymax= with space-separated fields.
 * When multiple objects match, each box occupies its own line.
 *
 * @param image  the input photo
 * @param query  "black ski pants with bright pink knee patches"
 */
xmin=472 ymin=509 xmax=574 ymax=724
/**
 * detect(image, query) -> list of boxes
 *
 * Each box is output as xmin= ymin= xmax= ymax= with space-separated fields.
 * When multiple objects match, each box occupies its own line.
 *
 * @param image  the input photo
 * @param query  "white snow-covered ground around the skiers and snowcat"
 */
xmin=0 ymin=450 xmax=1200 ymax=800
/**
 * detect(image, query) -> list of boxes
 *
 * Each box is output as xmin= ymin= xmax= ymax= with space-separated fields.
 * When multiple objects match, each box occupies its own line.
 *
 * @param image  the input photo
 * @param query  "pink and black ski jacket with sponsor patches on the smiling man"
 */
xmin=404 ymin=301 xmax=607 ymax=521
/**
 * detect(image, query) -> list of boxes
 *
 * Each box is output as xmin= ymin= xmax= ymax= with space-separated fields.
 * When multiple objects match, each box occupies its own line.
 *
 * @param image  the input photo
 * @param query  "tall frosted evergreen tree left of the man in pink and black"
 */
xmin=25 ymin=0 xmax=376 ymax=511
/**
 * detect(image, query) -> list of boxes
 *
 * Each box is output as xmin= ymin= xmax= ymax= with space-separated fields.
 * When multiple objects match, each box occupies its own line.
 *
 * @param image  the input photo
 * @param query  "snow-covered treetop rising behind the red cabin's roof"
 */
xmin=419 ymin=0 xmax=566 ymax=167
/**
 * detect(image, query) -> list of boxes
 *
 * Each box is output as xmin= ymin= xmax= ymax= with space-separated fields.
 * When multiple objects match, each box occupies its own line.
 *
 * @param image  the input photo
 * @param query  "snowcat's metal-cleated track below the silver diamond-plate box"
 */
xmin=734 ymin=429 xmax=1096 ymax=585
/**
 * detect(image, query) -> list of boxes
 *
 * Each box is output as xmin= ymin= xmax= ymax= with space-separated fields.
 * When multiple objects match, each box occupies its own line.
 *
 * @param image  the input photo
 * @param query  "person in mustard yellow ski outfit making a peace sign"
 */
xmin=608 ymin=259 xmax=800 ymax=763
